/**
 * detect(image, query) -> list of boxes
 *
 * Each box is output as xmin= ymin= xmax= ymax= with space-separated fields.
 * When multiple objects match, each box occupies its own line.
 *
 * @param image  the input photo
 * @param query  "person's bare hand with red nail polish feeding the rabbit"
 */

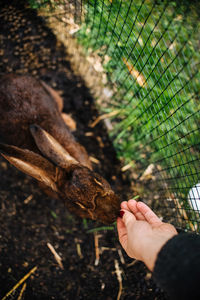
xmin=117 ymin=200 xmax=177 ymax=271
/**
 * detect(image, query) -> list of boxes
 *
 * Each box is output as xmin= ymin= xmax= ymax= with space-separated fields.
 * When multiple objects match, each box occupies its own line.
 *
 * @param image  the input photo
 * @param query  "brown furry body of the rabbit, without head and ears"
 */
xmin=0 ymin=74 xmax=91 ymax=168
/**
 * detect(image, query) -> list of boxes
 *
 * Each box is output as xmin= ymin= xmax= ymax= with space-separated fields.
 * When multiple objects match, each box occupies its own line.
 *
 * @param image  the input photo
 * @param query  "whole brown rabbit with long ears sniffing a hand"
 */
xmin=0 ymin=74 xmax=120 ymax=224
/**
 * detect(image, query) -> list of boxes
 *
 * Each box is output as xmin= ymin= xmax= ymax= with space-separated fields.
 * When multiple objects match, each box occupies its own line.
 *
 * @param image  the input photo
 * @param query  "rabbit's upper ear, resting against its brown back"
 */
xmin=30 ymin=125 xmax=79 ymax=169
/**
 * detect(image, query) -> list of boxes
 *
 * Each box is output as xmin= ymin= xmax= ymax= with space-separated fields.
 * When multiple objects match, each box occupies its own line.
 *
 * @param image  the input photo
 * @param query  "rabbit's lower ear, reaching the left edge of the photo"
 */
xmin=0 ymin=143 xmax=57 ymax=191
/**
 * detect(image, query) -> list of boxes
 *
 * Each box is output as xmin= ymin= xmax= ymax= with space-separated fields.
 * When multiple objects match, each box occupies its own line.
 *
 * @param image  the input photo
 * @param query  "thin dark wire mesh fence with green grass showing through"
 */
xmin=30 ymin=0 xmax=200 ymax=232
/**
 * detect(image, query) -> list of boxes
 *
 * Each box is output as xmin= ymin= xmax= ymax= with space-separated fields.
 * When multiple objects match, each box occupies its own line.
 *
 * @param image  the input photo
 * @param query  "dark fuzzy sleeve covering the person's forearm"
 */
xmin=153 ymin=234 xmax=200 ymax=300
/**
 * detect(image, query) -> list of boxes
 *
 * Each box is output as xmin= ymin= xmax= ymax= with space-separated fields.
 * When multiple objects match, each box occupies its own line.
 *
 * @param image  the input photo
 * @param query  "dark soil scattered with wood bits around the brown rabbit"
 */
xmin=0 ymin=1 xmax=165 ymax=300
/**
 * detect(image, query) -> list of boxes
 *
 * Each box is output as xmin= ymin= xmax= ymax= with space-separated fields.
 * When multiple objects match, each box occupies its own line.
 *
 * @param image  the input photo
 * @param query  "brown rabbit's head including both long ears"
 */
xmin=0 ymin=125 xmax=120 ymax=224
